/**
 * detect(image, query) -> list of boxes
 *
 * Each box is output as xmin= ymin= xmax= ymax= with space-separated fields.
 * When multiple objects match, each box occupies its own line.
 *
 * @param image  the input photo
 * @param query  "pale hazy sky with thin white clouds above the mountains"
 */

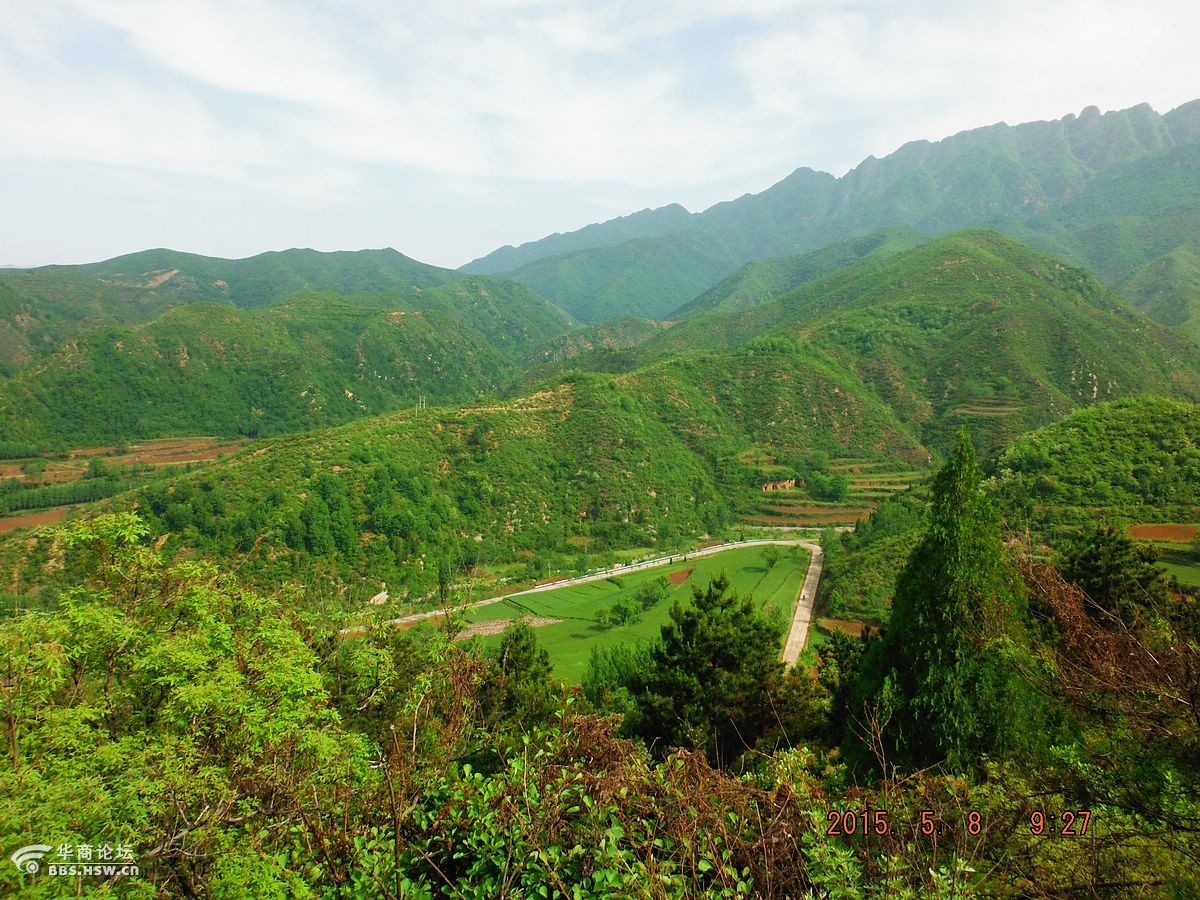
xmin=0 ymin=0 xmax=1200 ymax=266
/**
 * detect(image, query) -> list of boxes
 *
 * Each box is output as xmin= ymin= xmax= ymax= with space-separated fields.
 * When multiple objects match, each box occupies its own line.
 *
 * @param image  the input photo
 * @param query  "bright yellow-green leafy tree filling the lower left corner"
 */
xmin=0 ymin=515 xmax=366 ymax=893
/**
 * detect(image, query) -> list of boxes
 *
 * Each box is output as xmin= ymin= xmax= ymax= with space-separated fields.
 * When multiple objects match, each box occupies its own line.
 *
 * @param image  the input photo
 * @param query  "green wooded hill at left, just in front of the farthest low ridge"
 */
xmin=0 ymin=277 xmax=569 ymax=445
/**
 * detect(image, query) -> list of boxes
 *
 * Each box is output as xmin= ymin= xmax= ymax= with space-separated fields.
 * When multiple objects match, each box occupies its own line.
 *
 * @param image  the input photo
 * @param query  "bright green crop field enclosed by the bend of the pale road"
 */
xmin=467 ymin=546 xmax=809 ymax=684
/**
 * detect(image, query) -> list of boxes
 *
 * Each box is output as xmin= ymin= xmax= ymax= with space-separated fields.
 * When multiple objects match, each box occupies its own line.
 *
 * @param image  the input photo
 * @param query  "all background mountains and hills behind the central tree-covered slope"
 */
xmin=0 ymin=101 xmax=1200 ymax=460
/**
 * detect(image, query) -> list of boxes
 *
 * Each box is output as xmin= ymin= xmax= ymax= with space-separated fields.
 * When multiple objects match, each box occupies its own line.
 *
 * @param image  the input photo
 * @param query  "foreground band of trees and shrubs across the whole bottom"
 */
xmin=0 ymin=433 xmax=1200 ymax=898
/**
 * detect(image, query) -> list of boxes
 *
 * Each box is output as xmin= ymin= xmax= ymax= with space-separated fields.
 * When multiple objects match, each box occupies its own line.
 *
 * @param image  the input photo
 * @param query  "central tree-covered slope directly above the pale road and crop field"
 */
xmin=2 ymin=376 xmax=728 ymax=599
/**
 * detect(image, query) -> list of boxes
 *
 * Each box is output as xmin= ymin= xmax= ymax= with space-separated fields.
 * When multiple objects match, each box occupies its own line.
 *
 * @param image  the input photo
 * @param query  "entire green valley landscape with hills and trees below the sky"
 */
xmin=7 ymin=101 xmax=1200 ymax=898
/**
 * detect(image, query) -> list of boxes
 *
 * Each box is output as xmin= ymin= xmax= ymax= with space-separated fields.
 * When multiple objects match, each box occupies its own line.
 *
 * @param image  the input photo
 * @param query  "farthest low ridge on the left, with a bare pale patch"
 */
xmin=0 ymin=250 xmax=458 ymax=376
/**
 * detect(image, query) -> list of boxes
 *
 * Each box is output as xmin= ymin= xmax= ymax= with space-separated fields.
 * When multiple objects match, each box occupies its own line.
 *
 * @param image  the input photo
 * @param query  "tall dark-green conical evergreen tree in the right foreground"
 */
xmin=871 ymin=428 xmax=1024 ymax=769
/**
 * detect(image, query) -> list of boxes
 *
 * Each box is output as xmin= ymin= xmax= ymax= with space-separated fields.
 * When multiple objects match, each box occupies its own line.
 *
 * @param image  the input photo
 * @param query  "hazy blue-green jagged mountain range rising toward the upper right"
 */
xmin=463 ymin=101 xmax=1200 ymax=336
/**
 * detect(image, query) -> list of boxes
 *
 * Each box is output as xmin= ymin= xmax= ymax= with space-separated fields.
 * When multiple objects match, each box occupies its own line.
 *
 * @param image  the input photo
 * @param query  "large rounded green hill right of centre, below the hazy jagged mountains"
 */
xmin=576 ymin=230 xmax=1200 ymax=458
